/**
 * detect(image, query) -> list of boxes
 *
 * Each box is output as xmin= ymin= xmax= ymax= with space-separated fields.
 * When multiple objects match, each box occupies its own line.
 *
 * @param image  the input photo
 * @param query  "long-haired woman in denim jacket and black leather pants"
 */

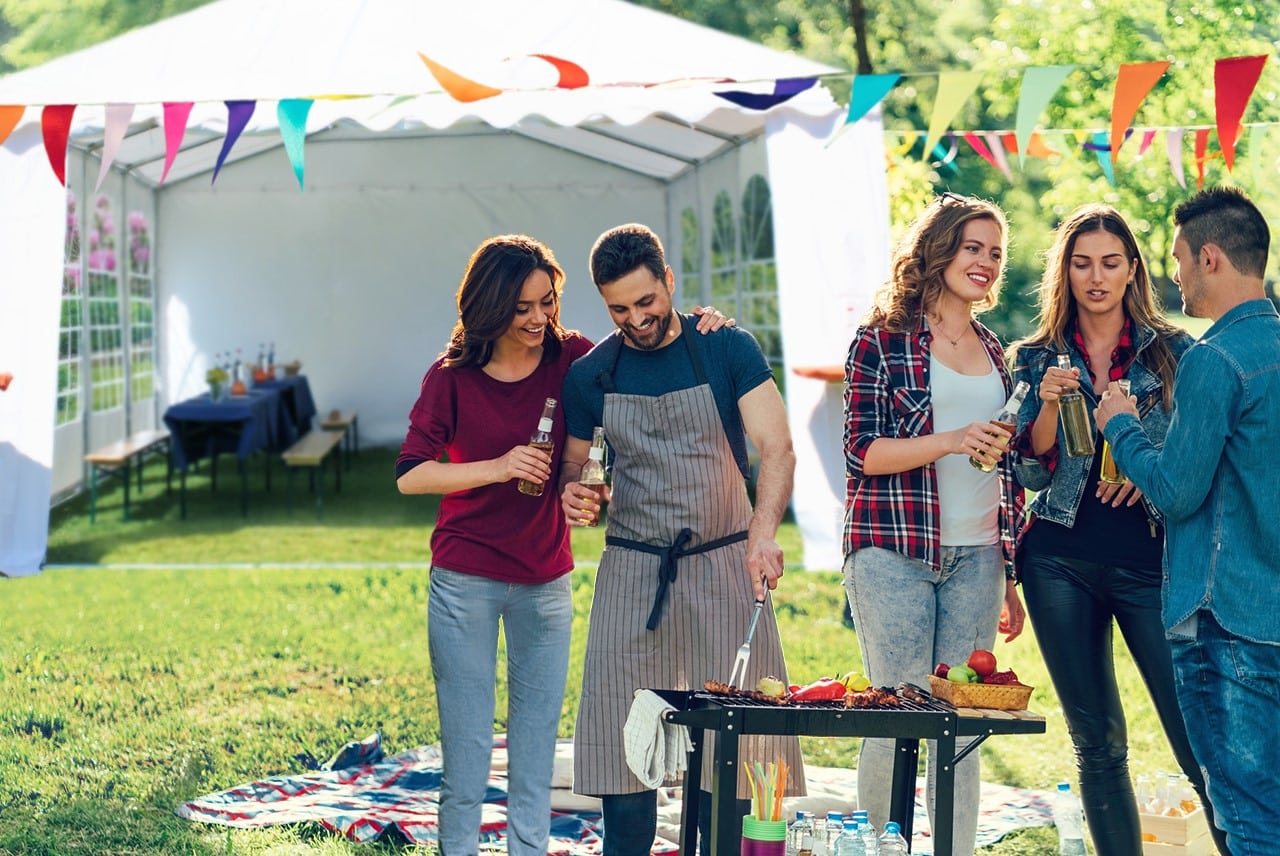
xmin=1010 ymin=205 xmax=1228 ymax=856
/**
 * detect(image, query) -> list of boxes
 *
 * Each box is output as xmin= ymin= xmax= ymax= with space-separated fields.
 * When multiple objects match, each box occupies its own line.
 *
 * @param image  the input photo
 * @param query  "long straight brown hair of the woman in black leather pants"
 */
xmin=1009 ymin=202 xmax=1181 ymax=411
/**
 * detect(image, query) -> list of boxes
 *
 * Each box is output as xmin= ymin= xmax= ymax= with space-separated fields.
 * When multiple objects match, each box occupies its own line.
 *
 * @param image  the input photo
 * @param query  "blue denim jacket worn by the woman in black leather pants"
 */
xmin=1012 ymin=328 xmax=1194 ymax=534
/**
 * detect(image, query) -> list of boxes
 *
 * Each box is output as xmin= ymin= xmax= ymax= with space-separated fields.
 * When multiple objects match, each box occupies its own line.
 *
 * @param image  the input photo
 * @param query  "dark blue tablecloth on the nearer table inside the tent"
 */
xmin=164 ymin=389 xmax=287 ymax=471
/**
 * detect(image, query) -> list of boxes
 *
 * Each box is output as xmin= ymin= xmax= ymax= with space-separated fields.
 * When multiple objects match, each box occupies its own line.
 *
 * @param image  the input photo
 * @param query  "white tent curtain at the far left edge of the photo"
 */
xmin=0 ymin=124 xmax=67 ymax=577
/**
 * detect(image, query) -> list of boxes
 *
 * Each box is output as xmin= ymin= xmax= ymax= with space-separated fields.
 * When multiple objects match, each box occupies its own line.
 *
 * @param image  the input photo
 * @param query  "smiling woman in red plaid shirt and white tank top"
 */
xmin=845 ymin=193 xmax=1023 ymax=853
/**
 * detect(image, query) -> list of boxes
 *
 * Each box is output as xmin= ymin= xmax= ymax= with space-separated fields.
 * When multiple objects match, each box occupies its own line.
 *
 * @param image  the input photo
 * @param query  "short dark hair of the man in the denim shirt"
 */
xmin=1174 ymin=187 xmax=1271 ymax=278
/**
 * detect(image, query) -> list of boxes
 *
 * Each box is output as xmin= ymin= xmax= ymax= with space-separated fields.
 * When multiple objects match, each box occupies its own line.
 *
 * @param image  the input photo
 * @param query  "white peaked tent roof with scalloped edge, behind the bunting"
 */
xmin=0 ymin=0 xmax=841 ymax=184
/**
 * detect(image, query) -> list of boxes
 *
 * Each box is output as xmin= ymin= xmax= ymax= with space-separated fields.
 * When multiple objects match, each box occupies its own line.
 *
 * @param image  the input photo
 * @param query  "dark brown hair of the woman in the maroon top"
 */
xmin=440 ymin=235 xmax=568 ymax=369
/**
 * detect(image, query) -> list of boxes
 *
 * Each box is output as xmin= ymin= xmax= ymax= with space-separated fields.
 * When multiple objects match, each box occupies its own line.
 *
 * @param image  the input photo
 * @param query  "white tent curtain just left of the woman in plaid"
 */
xmin=765 ymin=113 xmax=890 ymax=571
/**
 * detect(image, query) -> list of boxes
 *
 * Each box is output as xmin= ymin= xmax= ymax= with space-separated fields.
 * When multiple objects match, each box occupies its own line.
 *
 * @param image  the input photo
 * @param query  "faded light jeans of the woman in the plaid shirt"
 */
xmin=845 ymin=545 xmax=1005 ymax=853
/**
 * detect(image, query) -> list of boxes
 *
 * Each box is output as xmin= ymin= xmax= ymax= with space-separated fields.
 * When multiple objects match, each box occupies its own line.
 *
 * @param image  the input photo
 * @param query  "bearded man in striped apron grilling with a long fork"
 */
xmin=561 ymin=224 xmax=804 ymax=856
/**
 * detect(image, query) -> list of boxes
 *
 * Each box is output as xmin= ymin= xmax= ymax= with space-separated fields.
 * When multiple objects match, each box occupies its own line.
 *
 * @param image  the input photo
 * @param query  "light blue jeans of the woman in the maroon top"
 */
xmin=426 ymin=567 xmax=573 ymax=856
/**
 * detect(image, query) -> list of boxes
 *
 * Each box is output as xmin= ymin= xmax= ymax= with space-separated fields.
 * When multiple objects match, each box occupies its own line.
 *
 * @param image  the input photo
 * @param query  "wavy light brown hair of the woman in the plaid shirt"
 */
xmin=863 ymin=193 xmax=1009 ymax=333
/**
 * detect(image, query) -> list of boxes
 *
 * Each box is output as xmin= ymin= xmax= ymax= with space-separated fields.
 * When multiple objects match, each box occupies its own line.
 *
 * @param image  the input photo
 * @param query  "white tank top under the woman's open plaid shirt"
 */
xmin=929 ymin=354 xmax=1005 ymax=546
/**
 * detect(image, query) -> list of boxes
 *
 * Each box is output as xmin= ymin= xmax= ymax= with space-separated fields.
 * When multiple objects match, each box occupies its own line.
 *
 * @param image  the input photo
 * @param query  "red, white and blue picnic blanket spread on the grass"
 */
xmin=177 ymin=734 xmax=1052 ymax=856
